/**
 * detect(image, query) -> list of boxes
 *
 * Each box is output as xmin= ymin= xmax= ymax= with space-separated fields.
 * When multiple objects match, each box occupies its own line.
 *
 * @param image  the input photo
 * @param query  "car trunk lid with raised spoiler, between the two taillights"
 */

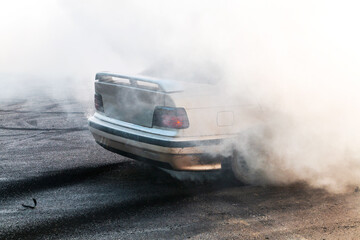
xmin=95 ymin=73 xmax=183 ymax=127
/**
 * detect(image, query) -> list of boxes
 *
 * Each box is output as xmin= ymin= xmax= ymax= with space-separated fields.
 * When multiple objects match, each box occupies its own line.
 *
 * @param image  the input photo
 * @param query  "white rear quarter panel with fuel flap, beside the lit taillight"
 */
xmin=166 ymin=91 xmax=261 ymax=137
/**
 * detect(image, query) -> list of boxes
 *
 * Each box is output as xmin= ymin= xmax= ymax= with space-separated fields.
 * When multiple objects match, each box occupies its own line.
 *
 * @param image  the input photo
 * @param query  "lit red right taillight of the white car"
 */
xmin=153 ymin=107 xmax=189 ymax=129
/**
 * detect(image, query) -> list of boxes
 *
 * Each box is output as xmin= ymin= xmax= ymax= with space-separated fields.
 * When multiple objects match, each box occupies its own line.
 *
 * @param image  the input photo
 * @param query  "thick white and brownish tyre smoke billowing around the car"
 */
xmin=0 ymin=0 xmax=360 ymax=191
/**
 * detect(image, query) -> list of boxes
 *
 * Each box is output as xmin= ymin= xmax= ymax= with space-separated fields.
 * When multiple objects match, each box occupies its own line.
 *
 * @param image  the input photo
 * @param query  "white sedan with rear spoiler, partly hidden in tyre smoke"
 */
xmin=89 ymin=72 xmax=258 ymax=181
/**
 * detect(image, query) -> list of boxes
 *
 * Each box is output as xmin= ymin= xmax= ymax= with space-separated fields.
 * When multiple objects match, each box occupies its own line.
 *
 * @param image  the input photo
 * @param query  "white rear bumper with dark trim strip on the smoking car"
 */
xmin=89 ymin=114 xmax=226 ymax=171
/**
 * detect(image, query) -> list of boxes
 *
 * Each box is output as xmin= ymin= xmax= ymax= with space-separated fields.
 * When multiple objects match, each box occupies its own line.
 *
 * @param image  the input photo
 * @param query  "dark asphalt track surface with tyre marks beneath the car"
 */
xmin=0 ymin=98 xmax=360 ymax=240
